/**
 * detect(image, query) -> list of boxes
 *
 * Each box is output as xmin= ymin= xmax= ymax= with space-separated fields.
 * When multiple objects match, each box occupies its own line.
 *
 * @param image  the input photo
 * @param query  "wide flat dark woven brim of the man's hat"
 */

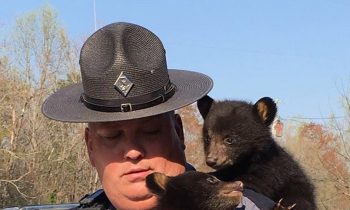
xmin=42 ymin=69 xmax=213 ymax=123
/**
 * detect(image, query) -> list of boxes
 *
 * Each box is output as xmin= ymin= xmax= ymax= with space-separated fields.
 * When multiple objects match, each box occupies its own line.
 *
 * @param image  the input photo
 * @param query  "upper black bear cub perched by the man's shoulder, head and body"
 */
xmin=197 ymin=96 xmax=316 ymax=210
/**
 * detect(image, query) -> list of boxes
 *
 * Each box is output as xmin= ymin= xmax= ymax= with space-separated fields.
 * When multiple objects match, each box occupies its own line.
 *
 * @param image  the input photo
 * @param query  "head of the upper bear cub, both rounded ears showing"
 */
xmin=197 ymin=96 xmax=277 ymax=169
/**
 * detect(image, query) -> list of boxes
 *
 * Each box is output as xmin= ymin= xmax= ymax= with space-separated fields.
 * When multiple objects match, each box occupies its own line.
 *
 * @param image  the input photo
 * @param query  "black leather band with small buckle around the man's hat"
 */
xmin=80 ymin=82 xmax=176 ymax=112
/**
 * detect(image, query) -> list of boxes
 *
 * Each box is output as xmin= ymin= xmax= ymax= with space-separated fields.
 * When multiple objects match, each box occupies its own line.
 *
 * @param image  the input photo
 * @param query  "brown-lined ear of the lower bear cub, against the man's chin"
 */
xmin=146 ymin=172 xmax=169 ymax=195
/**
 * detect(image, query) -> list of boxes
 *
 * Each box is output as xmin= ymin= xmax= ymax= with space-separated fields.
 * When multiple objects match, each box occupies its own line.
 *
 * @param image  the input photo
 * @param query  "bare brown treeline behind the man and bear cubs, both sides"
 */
xmin=0 ymin=7 xmax=350 ymax=210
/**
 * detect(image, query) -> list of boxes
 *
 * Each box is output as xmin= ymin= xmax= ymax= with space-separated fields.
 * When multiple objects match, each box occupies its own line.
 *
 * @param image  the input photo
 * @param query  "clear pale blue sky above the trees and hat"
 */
xmin=0 ymin=0 xmax=350 ymax=121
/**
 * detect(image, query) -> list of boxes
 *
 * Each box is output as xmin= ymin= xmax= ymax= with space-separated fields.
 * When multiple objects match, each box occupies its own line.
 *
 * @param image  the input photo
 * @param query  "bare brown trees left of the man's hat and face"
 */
xmin=0 ymin=7 xmax=99 ymax=206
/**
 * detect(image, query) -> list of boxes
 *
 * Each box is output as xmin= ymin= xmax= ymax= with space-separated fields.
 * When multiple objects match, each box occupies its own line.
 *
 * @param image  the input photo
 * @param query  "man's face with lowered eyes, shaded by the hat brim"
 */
xmin=85 ymin=113 xmax=186 ymax=209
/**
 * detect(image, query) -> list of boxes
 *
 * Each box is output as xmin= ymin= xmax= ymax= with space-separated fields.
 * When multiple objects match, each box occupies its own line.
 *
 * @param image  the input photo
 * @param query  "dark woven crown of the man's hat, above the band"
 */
xmin=80 ymin=23 xmax=169 ymax=100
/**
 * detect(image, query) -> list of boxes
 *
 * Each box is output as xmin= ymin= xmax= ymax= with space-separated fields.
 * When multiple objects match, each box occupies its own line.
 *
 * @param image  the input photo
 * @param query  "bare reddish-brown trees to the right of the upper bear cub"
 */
xmin=284 ymin=120 xmax=350 ymax=209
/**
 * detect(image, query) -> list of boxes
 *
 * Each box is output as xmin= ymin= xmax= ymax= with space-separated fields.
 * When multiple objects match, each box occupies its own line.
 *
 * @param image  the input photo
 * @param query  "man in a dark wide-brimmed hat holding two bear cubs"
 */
xmin=42 ymin=23 xmax=274 ymax=209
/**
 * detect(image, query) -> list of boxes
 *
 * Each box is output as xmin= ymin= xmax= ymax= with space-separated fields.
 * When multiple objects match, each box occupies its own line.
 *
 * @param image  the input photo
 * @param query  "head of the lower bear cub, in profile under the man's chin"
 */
xmin=146 ymin=171 xmax=243 ymax=210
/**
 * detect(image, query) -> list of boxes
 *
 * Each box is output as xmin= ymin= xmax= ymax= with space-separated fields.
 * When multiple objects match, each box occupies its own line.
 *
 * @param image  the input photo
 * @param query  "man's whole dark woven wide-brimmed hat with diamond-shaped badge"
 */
xmin=42 ymin=23 xmax=213 ymax=122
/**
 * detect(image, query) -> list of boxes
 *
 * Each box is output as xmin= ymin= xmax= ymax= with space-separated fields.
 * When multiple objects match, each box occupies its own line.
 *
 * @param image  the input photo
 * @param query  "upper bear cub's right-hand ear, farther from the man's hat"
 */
xmin=253 ymin=97 xmax=277 ymax=126
